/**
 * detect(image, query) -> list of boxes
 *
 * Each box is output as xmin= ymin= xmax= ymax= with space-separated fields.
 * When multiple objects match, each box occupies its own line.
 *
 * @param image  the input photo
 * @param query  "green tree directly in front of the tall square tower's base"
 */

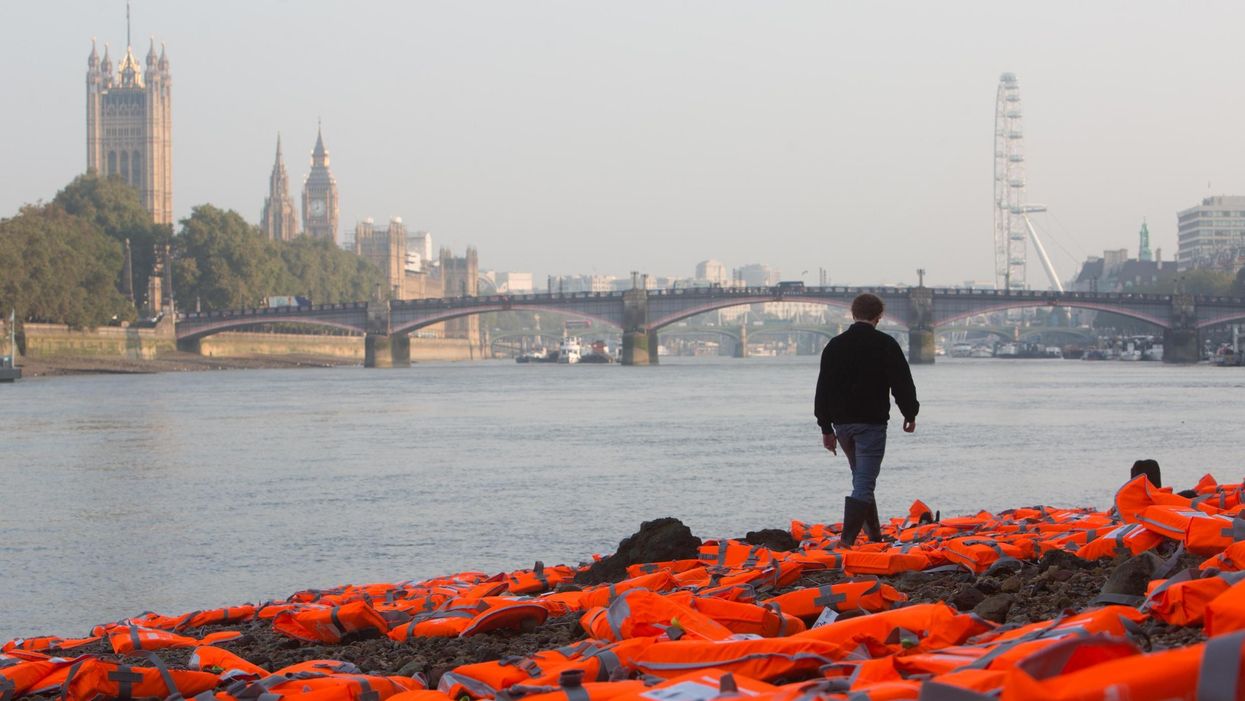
xmin=52 ymin=174 xmax=173 ymax=305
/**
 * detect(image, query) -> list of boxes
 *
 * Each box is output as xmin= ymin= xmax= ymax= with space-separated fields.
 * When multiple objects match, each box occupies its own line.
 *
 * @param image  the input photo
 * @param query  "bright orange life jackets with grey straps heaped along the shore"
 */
xmin=7 ymin=476 xmax=1245 ymax=701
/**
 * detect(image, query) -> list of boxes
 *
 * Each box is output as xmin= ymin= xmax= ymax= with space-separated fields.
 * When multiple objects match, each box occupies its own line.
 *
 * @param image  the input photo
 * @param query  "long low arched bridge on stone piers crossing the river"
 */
xmin=177 ymin=285 xmax=1245 ymax=367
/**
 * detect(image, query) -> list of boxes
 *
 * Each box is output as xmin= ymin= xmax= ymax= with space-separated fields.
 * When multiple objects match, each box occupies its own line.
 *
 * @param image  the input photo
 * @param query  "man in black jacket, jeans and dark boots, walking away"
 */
xmin=813 ymin=293 xmax=920 ymax=547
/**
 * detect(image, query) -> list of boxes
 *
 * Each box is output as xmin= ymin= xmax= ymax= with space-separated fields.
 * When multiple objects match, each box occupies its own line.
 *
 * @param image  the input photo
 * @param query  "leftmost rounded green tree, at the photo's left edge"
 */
xmin=0 ymin=204 xmax=133 ymax=327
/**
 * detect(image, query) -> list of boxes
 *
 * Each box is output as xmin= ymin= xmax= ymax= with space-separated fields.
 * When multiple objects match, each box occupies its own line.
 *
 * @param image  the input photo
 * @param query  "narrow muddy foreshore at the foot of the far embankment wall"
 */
xmin=17 ymin=352 xmax=359 ymax=380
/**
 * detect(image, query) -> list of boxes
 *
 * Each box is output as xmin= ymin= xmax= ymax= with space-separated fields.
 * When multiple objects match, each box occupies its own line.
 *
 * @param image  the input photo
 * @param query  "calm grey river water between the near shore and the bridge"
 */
xmin=0 ymin=356 xmax=1245 ymax=641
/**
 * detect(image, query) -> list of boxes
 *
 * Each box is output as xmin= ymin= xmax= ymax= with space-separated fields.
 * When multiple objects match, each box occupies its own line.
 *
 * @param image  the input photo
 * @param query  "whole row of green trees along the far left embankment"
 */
xmin=0 ymin=174 xmax=387 ymax=327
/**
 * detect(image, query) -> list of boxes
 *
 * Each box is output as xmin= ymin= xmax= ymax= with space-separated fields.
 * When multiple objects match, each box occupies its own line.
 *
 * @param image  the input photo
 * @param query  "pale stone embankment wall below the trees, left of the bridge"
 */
xmin=20 ymin=321 xmax=177 ymax=360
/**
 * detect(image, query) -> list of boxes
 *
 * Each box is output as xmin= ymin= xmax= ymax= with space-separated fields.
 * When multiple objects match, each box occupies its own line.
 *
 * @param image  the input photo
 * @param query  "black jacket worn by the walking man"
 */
xmin=813 ymin=321 xmax=921 ymax=433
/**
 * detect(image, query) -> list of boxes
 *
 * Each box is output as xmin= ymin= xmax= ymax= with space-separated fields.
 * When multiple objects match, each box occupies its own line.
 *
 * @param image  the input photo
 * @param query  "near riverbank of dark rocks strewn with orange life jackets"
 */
xmin=7 ymin=477 xmax=1245 ymax=701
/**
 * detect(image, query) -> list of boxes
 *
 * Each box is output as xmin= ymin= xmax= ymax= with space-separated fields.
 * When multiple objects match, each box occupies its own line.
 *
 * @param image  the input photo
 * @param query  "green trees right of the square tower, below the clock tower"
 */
xmin=173 ymin=204 xmax=381 ymax=310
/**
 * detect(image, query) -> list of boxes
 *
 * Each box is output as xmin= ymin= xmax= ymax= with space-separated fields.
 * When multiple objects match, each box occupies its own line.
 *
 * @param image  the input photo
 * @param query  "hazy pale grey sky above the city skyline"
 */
xmin=0 ymin=0 xmax=1245 ymax=286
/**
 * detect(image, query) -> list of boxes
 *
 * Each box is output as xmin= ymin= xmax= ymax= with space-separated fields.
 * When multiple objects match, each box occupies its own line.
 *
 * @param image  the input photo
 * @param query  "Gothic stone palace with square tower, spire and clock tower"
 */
xmin=86 ymin=26 xmax=479 ymax=341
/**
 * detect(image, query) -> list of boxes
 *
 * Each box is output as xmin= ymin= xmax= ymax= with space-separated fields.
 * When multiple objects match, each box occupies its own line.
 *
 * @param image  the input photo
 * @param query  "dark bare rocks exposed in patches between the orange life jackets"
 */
xmin=7 ymin=495 xmax=1225 ymax=699
